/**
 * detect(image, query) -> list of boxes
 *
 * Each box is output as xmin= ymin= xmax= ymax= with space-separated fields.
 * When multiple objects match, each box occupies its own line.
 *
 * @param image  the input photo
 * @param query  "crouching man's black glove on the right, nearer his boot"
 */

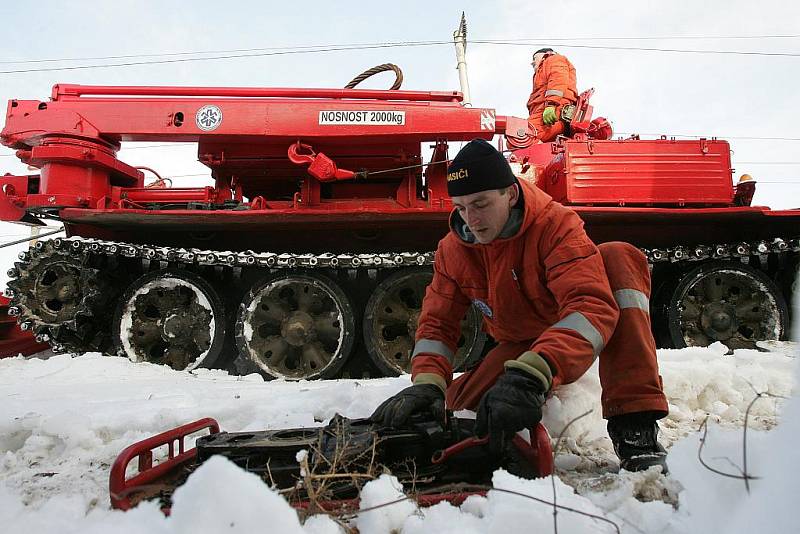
xmin=475 ymin=368 xmax=546 ymax=456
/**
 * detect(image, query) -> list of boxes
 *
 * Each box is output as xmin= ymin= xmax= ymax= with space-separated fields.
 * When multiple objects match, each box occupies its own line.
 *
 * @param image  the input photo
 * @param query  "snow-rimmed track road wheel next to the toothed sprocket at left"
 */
xmin=114 ymin=270 xmax=225 ymax=371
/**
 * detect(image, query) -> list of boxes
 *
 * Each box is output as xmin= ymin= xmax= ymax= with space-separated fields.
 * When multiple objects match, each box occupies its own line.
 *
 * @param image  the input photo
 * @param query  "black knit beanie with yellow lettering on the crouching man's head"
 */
xmin=447 ymin=139 xmax=517 ymax=197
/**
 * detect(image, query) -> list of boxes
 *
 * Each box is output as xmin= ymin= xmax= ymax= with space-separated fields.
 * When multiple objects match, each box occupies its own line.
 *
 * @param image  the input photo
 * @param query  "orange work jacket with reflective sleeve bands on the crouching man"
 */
xmin=412 ymin=182 xmax=619 ymax=385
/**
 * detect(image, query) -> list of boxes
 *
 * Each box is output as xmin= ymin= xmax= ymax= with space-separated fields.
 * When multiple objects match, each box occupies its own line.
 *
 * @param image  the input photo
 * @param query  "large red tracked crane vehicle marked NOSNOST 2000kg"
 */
xmin=0 ymin=72 xmax=800 ymax=379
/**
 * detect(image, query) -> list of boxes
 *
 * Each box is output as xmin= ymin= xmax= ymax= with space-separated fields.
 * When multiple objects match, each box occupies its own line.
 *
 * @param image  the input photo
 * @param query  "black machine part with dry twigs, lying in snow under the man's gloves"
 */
xmin=196 ymin=414 xmax=535 ymax=499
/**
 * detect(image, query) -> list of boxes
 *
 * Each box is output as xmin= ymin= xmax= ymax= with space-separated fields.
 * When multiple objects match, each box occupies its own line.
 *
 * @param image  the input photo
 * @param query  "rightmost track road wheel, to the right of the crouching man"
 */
xmin=667 ymin=261 xmax=788 ymax=349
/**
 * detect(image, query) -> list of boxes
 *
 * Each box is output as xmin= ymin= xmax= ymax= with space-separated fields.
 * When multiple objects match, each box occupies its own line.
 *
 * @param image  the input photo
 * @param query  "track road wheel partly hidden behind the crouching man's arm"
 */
xmin=364 ymin=269 xmax=486 ymax=376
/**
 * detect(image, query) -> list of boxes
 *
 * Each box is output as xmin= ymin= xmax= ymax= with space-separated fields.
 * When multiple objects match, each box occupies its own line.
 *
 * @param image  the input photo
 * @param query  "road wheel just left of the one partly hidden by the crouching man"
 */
xmin=235 ymin=272 xmax=355 ymax=380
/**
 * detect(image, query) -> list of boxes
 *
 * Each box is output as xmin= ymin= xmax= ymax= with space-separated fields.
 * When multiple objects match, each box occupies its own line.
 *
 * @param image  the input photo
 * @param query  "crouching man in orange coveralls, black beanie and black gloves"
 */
xmin=372 ymin=139 xmax=668 ymax=473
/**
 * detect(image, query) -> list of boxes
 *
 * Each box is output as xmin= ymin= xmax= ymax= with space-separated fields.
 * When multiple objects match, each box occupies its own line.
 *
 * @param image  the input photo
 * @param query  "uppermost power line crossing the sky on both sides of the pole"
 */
xmin=0 ymin=35 xmax=800 ymax=65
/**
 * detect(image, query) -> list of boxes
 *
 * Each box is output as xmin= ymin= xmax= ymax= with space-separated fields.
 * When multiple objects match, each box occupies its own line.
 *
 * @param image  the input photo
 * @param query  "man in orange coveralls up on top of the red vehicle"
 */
xmin=528 ymin=48 xmax=578 ymax=143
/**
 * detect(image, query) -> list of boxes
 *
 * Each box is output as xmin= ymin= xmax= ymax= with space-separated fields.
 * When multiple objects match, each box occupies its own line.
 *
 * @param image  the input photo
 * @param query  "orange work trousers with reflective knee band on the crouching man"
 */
xmin=447 ymin=242 xmax=669 ymax=418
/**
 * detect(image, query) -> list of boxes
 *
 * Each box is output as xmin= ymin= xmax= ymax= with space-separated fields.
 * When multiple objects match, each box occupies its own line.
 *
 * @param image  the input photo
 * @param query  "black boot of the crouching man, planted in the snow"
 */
xmin=608 ymin=412 xmax=668 ymax=475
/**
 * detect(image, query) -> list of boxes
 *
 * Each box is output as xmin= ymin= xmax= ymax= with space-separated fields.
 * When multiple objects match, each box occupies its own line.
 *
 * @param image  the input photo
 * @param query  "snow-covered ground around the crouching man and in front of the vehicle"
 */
xmin=0 ymin=342 xmax=800 ymax=534
